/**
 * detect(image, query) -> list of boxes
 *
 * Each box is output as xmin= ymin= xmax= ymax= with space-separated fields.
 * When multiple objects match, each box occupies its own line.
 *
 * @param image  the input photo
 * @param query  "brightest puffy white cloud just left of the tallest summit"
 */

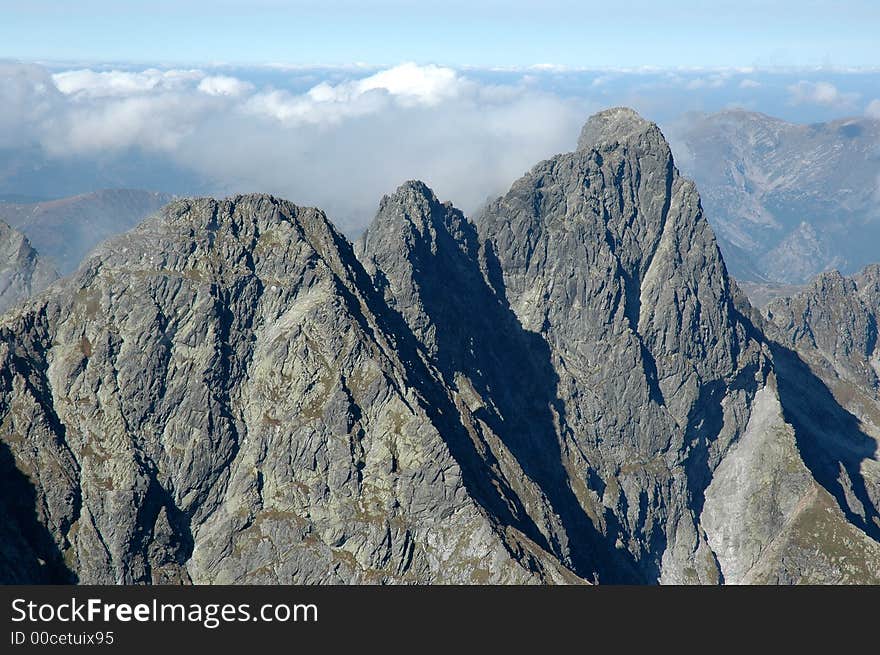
xmin=192 ymin=67 xmax=596 ymax=226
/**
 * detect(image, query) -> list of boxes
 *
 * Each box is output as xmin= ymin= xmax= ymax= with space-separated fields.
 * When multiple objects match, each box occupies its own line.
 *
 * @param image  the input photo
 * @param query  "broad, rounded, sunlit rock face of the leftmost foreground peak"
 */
xmin=0 ymin=196 xmax=575 ymax=583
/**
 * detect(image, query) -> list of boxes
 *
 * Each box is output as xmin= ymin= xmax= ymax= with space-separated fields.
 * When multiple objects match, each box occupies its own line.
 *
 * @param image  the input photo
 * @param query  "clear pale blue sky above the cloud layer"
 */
xmin=0 ymin=0 xmax=880 ymax=68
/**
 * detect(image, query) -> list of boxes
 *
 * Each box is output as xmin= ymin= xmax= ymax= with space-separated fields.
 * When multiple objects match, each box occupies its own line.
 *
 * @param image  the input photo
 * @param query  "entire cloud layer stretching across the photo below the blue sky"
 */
xmin=15 ymin=61 xmax=880 ymax=234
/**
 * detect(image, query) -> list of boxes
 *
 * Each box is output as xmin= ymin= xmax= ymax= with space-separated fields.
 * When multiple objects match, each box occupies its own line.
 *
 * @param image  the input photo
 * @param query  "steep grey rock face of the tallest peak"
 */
xmin=470 ymin=109 xmax=764 ymax=582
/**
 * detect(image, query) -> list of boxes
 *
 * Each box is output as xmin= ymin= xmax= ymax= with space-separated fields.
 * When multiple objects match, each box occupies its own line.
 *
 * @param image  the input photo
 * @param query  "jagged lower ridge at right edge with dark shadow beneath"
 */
xmin=762 ymin=266 xmax=880 ymax=581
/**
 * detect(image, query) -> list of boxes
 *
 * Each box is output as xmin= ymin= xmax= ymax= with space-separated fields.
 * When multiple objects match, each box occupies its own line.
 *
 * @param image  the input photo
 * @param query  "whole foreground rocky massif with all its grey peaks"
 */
xmin=0 ymin=108 xmax=880 ymax=584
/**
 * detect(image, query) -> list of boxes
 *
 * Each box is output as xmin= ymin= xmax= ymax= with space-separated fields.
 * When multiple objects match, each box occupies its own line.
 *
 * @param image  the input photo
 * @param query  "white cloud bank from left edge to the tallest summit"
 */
xmin=0 ymin=63 xmax=597 ymax=231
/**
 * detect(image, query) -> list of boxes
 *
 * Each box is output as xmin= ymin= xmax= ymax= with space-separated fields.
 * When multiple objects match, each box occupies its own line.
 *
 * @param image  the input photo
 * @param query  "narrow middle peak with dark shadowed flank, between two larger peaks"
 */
xmin=358 ymin=182 xmax=631 ymax=580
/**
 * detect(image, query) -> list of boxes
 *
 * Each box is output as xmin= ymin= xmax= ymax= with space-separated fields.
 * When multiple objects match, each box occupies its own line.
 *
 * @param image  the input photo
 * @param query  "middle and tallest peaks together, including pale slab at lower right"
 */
xmin=359 ymin=110 xmax=878 ymax=582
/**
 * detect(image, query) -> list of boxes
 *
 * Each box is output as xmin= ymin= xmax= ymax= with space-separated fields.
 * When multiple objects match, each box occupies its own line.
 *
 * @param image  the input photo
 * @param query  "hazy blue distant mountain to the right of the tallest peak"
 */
xmin=673 ymin=110 xmax=880 ymax=284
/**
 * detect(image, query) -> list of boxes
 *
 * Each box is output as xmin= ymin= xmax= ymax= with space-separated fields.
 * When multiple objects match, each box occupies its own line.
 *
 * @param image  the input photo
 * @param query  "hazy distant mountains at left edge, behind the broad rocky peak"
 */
xmin=0 ymin=189 xmax=172 ymax=275
